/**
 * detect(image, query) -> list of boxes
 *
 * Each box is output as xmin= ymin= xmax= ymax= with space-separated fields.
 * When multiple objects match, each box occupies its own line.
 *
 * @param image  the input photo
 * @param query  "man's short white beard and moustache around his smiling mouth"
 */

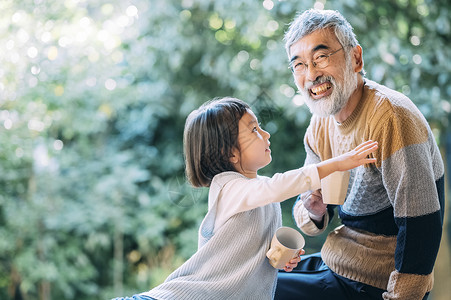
xmin=299 ymin=61 xmax=358 ymax=117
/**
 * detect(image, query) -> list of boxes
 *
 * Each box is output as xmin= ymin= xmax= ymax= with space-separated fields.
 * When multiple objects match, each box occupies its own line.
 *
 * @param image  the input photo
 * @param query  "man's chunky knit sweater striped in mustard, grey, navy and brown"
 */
xmin=293 ymin=80 xmax=444 ymax=299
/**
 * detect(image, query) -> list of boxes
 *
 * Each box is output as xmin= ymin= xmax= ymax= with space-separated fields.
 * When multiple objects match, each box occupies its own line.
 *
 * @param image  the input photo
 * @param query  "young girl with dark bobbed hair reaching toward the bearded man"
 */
xmin=116 ymin=98 xmax=377 ymax=300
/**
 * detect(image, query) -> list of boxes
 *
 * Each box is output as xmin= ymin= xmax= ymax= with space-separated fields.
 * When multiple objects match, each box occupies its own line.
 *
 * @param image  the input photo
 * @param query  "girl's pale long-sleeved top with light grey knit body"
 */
xmin=117 ymin=166 xmax=320 ymax=300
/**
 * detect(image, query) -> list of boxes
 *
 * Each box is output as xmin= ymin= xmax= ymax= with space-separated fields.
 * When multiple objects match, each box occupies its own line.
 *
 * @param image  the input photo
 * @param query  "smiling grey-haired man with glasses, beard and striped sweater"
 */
xmin=275 ymin=10 xmax=444 ymax=300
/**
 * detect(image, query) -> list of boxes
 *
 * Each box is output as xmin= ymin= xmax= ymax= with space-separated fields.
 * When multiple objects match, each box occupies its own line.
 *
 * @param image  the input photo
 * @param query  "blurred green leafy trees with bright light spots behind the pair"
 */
xmin=0 ymin=0 xmax=451 ymax=299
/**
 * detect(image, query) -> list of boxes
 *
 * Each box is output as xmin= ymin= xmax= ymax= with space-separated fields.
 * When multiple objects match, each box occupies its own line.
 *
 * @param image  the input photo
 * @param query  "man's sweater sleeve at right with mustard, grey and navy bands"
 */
xmin=370 ymin=94 xmax=443 ymax=299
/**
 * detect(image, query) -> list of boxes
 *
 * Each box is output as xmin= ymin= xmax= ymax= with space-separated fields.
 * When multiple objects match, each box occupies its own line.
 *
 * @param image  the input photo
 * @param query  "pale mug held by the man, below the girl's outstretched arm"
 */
xmin=321 ymin=171 xmax=351 ymax=205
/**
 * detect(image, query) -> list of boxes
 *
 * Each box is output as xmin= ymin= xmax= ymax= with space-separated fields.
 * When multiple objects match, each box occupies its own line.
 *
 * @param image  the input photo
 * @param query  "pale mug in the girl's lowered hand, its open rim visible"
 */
xmin=266 ymin=227 xmax=305 ymax=269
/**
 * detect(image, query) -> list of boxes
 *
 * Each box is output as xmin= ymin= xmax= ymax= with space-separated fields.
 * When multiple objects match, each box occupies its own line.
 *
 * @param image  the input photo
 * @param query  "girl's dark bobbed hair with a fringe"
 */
xmin=183 ymin=97 xmax=250 ymax=187
